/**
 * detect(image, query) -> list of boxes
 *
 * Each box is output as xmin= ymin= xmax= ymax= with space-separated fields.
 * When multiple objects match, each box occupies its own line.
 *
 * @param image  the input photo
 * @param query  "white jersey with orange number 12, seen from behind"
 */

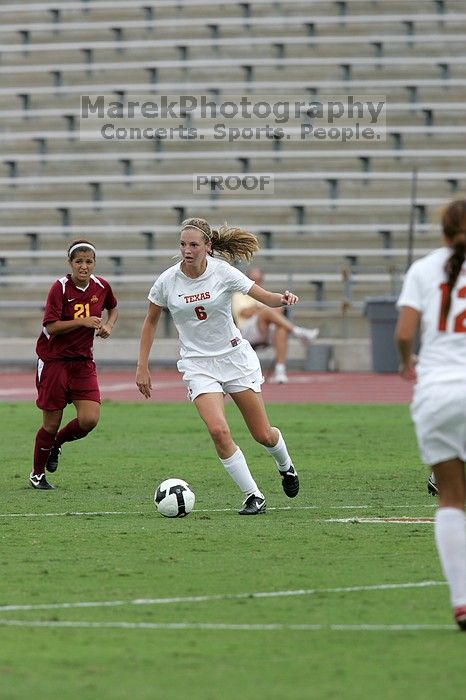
xmin=397 ymin=247 xmax=466 ymax=386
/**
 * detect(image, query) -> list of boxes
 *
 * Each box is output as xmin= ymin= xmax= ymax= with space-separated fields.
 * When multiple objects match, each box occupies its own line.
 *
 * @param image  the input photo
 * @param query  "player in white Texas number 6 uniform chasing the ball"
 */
xmin=136 ymin=218 xmax=299 ymax=515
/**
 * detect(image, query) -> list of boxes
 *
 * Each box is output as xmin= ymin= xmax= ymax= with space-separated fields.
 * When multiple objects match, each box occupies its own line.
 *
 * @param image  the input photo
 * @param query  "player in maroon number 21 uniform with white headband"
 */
xmin=29 ymin=239 xmax=118 ymax=490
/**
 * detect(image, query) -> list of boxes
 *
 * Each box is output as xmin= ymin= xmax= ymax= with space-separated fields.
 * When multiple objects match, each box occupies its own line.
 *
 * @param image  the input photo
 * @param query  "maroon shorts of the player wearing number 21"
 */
xmin=36 ymin=360 xmax=100 ymax=411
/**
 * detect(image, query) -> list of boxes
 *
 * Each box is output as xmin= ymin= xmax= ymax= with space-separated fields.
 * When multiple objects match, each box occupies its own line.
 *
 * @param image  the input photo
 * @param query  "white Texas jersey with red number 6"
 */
xmin=148 ymin=257 xmax=254 ymax=358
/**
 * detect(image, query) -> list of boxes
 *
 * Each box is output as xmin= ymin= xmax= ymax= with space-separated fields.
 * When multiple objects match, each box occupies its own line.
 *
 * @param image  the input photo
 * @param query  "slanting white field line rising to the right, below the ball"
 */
xmin=0 ymin=581 xmax=446 ymax=612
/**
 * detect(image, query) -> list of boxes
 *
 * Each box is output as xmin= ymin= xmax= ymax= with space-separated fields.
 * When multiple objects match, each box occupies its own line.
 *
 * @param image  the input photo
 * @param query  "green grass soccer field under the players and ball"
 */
xmin=0 ymin=402 xmax=466 ymax=700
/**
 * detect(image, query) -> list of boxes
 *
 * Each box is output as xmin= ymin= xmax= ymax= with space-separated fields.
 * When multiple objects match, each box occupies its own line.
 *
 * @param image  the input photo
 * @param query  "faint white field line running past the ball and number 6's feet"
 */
xmin=0 ymin=503 xmax=436 ymax=522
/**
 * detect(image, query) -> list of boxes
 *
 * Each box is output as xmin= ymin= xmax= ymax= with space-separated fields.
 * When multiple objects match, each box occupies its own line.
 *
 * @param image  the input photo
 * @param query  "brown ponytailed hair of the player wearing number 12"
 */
xmin=442 ymin=199 xmax=466 ymax=318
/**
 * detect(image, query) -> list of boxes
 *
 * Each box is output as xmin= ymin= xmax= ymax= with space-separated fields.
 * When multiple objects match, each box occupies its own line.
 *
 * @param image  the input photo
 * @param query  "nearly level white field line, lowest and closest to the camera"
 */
xmin=0 ymin=618 xmax=457 ymax=632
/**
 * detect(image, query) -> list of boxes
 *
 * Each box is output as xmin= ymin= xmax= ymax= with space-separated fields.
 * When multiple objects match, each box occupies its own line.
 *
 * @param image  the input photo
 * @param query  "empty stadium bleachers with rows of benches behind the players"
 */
xmin=0 ymin=0 xmax=466 ymax=370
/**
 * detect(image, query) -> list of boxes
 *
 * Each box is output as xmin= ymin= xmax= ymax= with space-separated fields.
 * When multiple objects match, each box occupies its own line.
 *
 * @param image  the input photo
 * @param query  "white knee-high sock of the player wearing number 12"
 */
xmin=435 ymin=508 xmax=466 ymax=607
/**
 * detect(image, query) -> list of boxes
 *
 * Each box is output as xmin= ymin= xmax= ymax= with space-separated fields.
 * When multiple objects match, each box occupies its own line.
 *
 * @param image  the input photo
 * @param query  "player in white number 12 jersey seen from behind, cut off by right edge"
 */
xmin=395 ymin=200 xmax=466 ymax=631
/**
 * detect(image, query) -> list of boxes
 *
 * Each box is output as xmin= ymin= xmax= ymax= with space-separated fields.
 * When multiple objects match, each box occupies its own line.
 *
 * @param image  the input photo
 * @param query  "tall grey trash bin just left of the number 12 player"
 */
xmin=364 ymin=296 xmax=398 ymax=372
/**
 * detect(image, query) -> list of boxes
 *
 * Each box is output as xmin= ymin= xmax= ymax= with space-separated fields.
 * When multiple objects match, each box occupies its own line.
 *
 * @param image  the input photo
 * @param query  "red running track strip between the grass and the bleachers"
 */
xmin=0 ymin=368 xmax=413 ymax=403
